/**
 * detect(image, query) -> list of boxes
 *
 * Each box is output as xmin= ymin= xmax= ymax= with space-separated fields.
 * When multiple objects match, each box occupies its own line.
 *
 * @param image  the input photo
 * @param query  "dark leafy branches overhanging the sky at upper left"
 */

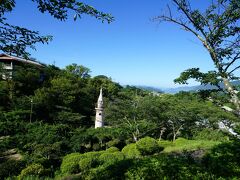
xmin=0 ymin=0 xmax=113 ymax=58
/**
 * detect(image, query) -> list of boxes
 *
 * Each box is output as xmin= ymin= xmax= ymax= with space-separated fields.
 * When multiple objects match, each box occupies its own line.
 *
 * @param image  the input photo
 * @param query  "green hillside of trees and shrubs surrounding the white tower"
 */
xmin=0 ymin=64 xmax=240 ymax=179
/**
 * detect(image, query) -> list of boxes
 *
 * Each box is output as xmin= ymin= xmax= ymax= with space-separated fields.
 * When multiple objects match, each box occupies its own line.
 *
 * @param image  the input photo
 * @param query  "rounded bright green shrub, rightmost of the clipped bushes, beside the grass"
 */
xmin=136 ymin=137 xmax=164 ymax=155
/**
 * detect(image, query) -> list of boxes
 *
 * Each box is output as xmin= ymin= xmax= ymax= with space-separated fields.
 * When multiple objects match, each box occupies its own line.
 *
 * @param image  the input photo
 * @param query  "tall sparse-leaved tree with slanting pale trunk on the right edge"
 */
xmin=155 ymin=0 xmax=240 ymax=114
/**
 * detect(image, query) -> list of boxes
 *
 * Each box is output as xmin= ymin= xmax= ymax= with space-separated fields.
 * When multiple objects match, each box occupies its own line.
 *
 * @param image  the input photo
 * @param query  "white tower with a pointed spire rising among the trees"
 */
xmin=95 ymin=88 xmax=104 ymax=129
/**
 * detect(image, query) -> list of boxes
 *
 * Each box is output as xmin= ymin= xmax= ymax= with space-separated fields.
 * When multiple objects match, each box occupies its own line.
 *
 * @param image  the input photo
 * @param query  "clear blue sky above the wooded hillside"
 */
xmin=4 ymin=0 xmax=213 ymax=87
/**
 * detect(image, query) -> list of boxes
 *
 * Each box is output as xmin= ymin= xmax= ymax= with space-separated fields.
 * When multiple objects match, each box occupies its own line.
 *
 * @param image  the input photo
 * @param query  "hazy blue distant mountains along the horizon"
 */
xmin=136 ymin=81 xmax=240 ymax=94
